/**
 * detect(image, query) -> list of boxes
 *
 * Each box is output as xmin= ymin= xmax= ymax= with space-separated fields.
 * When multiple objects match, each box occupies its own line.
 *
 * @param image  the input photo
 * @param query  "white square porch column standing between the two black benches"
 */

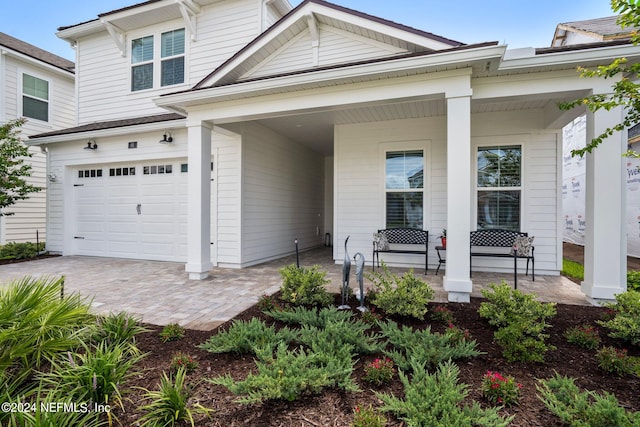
xmin=443 ymin=89 xmax=473 ymax=302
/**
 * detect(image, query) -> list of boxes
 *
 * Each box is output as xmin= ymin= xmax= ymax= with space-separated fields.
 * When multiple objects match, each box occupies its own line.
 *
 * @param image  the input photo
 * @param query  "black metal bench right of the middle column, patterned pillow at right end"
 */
xmin=469 ymin=229 xmax=536 ymax=289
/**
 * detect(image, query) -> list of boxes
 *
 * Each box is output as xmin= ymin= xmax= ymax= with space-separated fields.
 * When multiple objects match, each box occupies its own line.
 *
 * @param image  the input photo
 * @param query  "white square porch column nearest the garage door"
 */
xmin=185 ymin=122 xmax=213 ymax=280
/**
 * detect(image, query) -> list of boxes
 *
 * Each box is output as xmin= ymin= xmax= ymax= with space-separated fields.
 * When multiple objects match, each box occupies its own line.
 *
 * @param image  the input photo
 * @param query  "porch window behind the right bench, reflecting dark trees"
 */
xmin=477 ymin=146 xmax=522 ymax=231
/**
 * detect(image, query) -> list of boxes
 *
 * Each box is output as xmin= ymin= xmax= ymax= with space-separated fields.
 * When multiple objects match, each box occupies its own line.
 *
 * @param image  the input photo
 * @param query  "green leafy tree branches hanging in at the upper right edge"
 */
xmin=560 ymin=0 xmax=640 ymax=157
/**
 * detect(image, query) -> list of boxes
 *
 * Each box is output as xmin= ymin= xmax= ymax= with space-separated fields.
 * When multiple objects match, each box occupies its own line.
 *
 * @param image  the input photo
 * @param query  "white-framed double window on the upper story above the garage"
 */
xmin=131 ymin=28 xmax=185 ymax=92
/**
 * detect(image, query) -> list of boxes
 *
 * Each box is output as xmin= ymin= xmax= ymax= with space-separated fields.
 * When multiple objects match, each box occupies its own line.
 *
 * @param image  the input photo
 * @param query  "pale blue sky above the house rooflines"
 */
xmin=0 ymin=0 xmax=613 ymax=60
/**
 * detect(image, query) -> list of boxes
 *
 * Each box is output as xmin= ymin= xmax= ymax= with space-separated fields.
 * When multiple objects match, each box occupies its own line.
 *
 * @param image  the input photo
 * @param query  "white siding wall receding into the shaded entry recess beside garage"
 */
xmin=225 ymin=123 xmax=324 ymax=266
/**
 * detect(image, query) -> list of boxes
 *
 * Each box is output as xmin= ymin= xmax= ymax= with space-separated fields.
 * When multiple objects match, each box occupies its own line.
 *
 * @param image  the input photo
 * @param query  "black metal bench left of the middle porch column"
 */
xmin=371 ymin=228 xmax=429 ymax=274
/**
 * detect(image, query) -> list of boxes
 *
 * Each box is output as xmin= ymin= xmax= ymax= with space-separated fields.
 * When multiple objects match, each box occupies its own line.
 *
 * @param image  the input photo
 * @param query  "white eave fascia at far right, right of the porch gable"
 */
xmin=498 ymin=45 xmax=640 ymax=71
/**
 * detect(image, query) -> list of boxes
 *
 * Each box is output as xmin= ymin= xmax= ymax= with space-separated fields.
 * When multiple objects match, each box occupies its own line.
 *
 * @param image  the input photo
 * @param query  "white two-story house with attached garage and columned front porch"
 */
xmin=31 ymin=0 xmax=640 ymax=301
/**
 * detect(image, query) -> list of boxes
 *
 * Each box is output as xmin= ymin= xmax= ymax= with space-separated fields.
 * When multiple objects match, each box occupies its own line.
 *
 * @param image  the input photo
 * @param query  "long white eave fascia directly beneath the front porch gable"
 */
xmin=159 ymin=46 xmax=505 ymax=108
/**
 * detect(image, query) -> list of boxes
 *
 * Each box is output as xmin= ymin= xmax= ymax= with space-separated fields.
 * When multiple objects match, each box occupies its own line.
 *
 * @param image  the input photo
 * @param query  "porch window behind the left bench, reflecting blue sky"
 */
xmin=385 ymin=150 xmax=424 ymax=229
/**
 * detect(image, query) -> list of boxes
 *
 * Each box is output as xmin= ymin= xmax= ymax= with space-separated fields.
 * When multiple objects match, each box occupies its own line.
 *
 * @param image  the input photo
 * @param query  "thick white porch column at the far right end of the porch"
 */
xmin=582 ymin=108 xmax=627 ymax=300
